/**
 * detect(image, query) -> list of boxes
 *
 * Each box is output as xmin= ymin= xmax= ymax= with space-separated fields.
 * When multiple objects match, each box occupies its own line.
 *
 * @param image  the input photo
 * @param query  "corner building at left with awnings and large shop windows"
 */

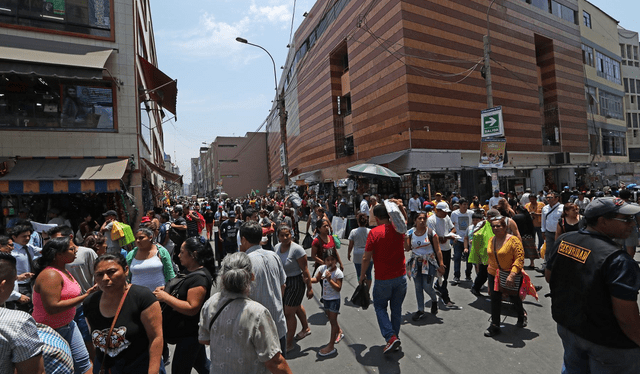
xmin=0 ymin=0 xmax=179 ymax=225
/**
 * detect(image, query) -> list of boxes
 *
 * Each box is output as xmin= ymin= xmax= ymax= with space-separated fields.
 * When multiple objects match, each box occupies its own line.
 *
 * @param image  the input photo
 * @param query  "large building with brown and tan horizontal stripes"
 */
xmin=267 ymin=0 xmax=596 ymax=197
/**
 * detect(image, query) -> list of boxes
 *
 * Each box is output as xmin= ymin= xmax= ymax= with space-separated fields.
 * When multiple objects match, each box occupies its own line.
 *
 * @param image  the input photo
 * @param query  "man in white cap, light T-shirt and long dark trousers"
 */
xmin=427 ymin=201 xmax=456 ymax=308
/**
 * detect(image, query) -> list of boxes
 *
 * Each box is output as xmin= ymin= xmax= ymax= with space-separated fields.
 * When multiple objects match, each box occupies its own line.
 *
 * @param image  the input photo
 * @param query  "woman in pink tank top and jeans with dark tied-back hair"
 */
xmin=33 ymin=236 xmax=97 ymax=374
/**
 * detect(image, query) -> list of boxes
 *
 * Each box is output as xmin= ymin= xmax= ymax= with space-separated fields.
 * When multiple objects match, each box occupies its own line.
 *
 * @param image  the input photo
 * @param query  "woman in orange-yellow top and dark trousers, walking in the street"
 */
xmin=484 ymin=216 xmax=527 ymax=337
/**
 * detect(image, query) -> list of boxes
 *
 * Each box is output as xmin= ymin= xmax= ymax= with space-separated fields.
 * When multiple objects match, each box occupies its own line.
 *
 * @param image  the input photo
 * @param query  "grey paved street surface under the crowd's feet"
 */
xmin=168 ymin=225 xmax=592 ymax=374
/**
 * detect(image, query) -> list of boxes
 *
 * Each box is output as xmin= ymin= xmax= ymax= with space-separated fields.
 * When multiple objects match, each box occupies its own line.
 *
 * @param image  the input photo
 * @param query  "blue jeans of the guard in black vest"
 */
xmin=558 ymin=325 xmax=640 ymax=374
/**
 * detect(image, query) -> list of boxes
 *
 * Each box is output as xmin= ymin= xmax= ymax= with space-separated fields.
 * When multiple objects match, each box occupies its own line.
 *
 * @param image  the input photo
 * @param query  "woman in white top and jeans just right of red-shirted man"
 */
xmin=404 ymin=211 xmax=445 ymax=321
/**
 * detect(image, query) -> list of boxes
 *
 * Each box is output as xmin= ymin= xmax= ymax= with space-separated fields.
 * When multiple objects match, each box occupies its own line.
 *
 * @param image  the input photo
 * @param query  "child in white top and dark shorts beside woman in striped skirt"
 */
xmin=311 ymin=248 xmax=344 ymax=357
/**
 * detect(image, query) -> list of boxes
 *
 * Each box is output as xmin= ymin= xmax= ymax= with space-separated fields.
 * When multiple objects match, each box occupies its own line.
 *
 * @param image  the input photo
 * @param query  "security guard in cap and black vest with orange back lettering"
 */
xmin=545 ymin=197 xmax=640 ymax=374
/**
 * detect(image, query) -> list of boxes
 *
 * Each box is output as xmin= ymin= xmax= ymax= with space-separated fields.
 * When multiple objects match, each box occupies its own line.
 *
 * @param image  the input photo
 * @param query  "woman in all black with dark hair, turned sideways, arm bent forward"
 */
xmin=153 ymin=236 xmax=216 ymax=374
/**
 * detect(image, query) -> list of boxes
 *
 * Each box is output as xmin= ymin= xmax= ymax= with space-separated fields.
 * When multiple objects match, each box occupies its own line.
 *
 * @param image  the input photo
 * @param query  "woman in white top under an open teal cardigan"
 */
xmin=127 ymin=227 xmax=176 ymax=292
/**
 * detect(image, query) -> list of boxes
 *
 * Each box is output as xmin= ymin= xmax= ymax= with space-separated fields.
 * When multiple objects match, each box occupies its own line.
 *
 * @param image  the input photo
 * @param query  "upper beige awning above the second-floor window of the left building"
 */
xmin=0 ymin=35 xmax=113 ymax=79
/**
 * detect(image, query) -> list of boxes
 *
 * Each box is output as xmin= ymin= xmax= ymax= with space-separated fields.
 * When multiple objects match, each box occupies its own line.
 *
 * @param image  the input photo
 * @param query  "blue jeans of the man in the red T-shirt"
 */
xmin=373 ymin=275 xmax=407 ymax=341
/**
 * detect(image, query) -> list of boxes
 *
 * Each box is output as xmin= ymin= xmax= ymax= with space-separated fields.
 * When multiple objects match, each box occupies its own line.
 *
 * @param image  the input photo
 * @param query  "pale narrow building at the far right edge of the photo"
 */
xmin=618 ymin=27 xmax=640 ymax=162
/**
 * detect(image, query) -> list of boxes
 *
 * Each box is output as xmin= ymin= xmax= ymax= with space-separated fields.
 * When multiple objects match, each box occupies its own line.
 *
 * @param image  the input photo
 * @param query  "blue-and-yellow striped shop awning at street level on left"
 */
xmin=0 ymin=158 xmax=128 ymax=195
